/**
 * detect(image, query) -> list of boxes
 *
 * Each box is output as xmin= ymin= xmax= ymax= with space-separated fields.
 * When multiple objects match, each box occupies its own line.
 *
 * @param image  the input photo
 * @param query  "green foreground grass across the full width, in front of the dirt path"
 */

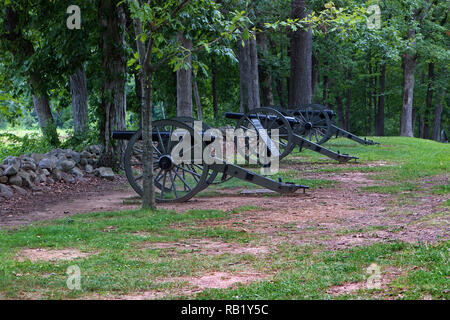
xmin=0 ymin=207 xmax=450 ymax=299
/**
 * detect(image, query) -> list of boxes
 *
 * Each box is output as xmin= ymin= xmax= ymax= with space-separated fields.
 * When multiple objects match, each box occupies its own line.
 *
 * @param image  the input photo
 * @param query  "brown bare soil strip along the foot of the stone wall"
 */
xmin=0 ymin=176 xmax=138 ymax=227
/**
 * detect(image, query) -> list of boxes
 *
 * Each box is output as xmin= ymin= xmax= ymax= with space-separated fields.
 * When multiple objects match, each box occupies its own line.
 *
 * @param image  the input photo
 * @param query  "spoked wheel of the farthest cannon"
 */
xmin=292 ymin=104 xmax=333 ymax=144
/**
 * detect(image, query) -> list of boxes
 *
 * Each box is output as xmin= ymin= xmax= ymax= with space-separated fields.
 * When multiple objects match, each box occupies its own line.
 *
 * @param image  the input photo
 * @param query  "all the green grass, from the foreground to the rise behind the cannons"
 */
xmin=0 ymin=134 xmax=450 ymax=299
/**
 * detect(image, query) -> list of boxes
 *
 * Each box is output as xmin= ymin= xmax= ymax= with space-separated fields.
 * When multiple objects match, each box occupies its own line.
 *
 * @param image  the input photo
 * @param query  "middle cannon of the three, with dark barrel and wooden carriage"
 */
xmin=225 ymin=108 xmax=358 ymax=162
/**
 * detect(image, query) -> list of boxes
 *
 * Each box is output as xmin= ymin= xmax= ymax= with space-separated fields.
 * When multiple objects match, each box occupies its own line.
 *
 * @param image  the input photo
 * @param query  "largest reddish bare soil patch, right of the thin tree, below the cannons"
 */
xmin=164 ymin=172 xmax=450 ymax=249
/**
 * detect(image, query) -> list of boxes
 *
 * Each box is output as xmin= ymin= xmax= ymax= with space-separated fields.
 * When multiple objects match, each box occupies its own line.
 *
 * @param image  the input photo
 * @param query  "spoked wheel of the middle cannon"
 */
xmin=236 ymin=108 xmax=294 ymax=161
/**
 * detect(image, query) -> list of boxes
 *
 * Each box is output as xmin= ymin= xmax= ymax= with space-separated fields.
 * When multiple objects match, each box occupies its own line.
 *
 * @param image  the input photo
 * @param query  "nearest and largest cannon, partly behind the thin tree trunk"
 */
xmin=112 ymin=117 xmax=309 ymax=203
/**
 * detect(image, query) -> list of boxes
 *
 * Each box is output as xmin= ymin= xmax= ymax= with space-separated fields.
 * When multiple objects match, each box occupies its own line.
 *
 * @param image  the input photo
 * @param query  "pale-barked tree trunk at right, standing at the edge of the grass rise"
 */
xmin=400 ymin=30 xmax=416 ymax=137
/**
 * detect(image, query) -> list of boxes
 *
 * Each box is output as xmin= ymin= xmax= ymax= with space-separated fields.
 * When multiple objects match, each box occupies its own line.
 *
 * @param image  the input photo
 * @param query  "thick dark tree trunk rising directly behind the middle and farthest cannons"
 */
xmin=288 ymin=0 xmax=312 ymax=109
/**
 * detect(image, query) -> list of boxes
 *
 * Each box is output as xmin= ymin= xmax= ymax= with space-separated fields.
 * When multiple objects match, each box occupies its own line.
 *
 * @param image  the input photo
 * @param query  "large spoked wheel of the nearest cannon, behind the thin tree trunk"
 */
xmin=124 ymin=120 xmax=211 ymax=203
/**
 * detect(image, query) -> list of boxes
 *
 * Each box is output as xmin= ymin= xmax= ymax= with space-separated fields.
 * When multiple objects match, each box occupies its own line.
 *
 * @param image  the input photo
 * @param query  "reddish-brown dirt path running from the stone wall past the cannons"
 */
xmin=0 ymin=171 xmax=450 ymax=249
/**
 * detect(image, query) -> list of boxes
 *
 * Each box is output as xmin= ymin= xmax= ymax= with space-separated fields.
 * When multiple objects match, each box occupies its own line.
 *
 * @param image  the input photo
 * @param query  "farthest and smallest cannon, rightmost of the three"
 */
xmin=271 ymin=103 xmax=379 ymax=145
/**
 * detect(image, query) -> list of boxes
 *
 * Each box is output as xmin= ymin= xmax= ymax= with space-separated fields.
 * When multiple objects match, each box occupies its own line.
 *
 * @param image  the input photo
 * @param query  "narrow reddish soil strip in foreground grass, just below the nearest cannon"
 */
xmin=140 ymin=239 xmax=269 ymax=255
